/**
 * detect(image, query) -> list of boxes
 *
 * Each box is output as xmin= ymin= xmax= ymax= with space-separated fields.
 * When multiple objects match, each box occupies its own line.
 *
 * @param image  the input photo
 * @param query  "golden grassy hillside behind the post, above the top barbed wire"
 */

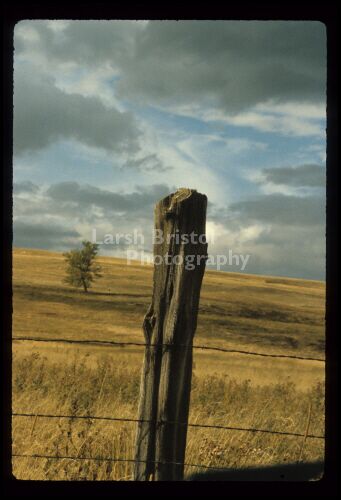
xmin=13 ymin=249 xmax=325 ymax=354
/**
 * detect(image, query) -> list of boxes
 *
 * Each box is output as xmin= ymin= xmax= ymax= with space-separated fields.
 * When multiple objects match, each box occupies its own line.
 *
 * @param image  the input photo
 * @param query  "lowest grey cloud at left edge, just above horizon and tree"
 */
xmin=13 ymin=220 xmax=80 ymax=250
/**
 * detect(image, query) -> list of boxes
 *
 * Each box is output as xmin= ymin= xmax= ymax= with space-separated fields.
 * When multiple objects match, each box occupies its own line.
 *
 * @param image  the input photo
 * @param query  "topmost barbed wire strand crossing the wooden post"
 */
xmin=12 ymin=337 xmax=325 ymax=363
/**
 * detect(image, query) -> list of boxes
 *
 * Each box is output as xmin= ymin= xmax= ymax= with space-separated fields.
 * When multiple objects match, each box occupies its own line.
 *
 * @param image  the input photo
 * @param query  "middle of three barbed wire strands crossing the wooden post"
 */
xmin=12 ymin=413 xmax=325 ymax=439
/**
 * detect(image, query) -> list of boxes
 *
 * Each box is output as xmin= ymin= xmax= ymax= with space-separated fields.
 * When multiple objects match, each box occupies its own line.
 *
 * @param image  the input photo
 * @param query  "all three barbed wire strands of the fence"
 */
xmin=12 ymin=336 xmax=325 ymax=470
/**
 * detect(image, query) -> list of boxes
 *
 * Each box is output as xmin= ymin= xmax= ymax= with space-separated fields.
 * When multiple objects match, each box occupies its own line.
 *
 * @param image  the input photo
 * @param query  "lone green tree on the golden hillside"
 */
xmin=63 ymin=241 xmax=102 ymax=292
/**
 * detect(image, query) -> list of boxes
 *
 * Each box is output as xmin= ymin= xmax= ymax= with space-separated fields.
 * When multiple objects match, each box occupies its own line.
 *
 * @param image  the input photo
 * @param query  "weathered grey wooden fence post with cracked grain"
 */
xmin=134 ymin=188 xmax=207 ymax=481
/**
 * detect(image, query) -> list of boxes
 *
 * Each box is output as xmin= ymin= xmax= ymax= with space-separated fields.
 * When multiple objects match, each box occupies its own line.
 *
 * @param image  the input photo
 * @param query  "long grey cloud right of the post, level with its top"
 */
xmin=229 ymin=193 xmax=325 ymax=226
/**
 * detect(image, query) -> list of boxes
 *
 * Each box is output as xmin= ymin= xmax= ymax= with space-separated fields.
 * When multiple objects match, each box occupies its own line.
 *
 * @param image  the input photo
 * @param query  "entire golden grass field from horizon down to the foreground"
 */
xmin=12 ymin=248 xmax=325 ymax=480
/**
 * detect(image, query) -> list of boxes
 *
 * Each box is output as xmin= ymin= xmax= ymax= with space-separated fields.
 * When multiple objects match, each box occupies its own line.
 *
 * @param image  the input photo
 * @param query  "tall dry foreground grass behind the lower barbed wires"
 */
xmin=12 ymin=353 xmax=324 ymax=480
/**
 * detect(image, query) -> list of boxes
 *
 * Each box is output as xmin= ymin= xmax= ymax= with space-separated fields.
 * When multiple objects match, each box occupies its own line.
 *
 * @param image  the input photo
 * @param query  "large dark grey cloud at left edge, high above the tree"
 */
xmin=14 ymin=68 xmax=139 ymax=154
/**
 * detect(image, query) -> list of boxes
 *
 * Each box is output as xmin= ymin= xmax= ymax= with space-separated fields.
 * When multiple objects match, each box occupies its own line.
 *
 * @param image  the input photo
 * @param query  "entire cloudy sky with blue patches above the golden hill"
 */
xmin=13 ymin=21 xmax=326 ymax=279
